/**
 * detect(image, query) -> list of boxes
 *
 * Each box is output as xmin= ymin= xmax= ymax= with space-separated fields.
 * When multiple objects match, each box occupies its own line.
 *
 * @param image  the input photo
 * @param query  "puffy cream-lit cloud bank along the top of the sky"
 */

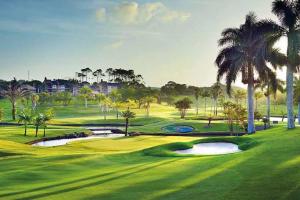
xmin=96 ymin=2 xmax=191 ymax=25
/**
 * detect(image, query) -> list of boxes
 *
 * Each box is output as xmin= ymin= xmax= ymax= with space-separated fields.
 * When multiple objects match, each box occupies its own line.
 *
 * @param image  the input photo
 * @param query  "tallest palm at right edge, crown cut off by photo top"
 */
xmin=272 ymin=0 xmax=300 ymax=129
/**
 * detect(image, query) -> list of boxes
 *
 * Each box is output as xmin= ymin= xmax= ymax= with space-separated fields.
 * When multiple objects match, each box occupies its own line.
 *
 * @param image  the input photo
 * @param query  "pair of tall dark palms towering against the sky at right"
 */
xmin=215 ymin=0 xmax=300 ymax=133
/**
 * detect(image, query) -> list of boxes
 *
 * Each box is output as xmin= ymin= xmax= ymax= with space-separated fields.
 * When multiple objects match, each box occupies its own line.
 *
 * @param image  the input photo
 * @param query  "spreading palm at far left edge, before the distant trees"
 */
xmin=1 ymin=78 xmax=29 ymax=121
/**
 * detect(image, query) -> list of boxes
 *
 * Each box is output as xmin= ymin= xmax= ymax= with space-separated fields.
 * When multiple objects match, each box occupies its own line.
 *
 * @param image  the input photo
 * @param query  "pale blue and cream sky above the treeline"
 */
xmin=0 ymin=0 xmax=285 ymax=86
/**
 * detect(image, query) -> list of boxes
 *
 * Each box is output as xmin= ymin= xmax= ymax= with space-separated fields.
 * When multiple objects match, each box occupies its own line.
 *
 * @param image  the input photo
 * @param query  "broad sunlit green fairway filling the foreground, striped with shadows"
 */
xmin=0 ymin=126 xmax=300 ymax=200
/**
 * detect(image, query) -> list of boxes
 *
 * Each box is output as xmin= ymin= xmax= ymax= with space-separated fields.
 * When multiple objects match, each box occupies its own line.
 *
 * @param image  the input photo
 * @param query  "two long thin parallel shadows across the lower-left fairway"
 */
xmin=6 ymin=159 xmax=176 ymax=200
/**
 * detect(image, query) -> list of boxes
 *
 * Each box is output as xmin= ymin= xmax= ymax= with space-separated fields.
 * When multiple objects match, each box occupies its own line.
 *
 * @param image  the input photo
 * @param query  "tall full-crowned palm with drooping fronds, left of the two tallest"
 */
xmin=215 ymin=13 xmax=279 ymax=133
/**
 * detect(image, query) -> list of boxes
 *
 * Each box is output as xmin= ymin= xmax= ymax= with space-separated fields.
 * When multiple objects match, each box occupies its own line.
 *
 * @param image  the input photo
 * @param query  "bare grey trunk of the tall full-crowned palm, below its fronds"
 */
xmin=247 ymin=81 xmax=255 ymax=134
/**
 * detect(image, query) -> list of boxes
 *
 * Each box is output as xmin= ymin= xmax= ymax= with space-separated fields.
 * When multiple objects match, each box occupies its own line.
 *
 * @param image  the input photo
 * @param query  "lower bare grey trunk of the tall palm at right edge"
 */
xmin=286 ymin=65 xmax=295 ymax=129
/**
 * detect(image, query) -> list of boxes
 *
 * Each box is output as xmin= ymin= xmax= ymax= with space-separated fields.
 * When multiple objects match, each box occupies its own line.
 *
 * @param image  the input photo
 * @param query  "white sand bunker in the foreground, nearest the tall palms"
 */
xmin=175 ymin=142 xmax=241 ymax=155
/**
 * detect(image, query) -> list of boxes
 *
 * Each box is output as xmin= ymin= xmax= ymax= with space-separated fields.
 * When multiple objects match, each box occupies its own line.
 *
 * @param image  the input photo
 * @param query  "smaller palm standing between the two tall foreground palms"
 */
xmin=255 ymin=72 xmax=284 ymax=127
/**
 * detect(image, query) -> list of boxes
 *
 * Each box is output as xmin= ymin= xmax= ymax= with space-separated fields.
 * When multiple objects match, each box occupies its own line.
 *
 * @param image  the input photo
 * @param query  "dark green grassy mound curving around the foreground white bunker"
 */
xmin=143 ymin=137 xmax=258 ymax=157
